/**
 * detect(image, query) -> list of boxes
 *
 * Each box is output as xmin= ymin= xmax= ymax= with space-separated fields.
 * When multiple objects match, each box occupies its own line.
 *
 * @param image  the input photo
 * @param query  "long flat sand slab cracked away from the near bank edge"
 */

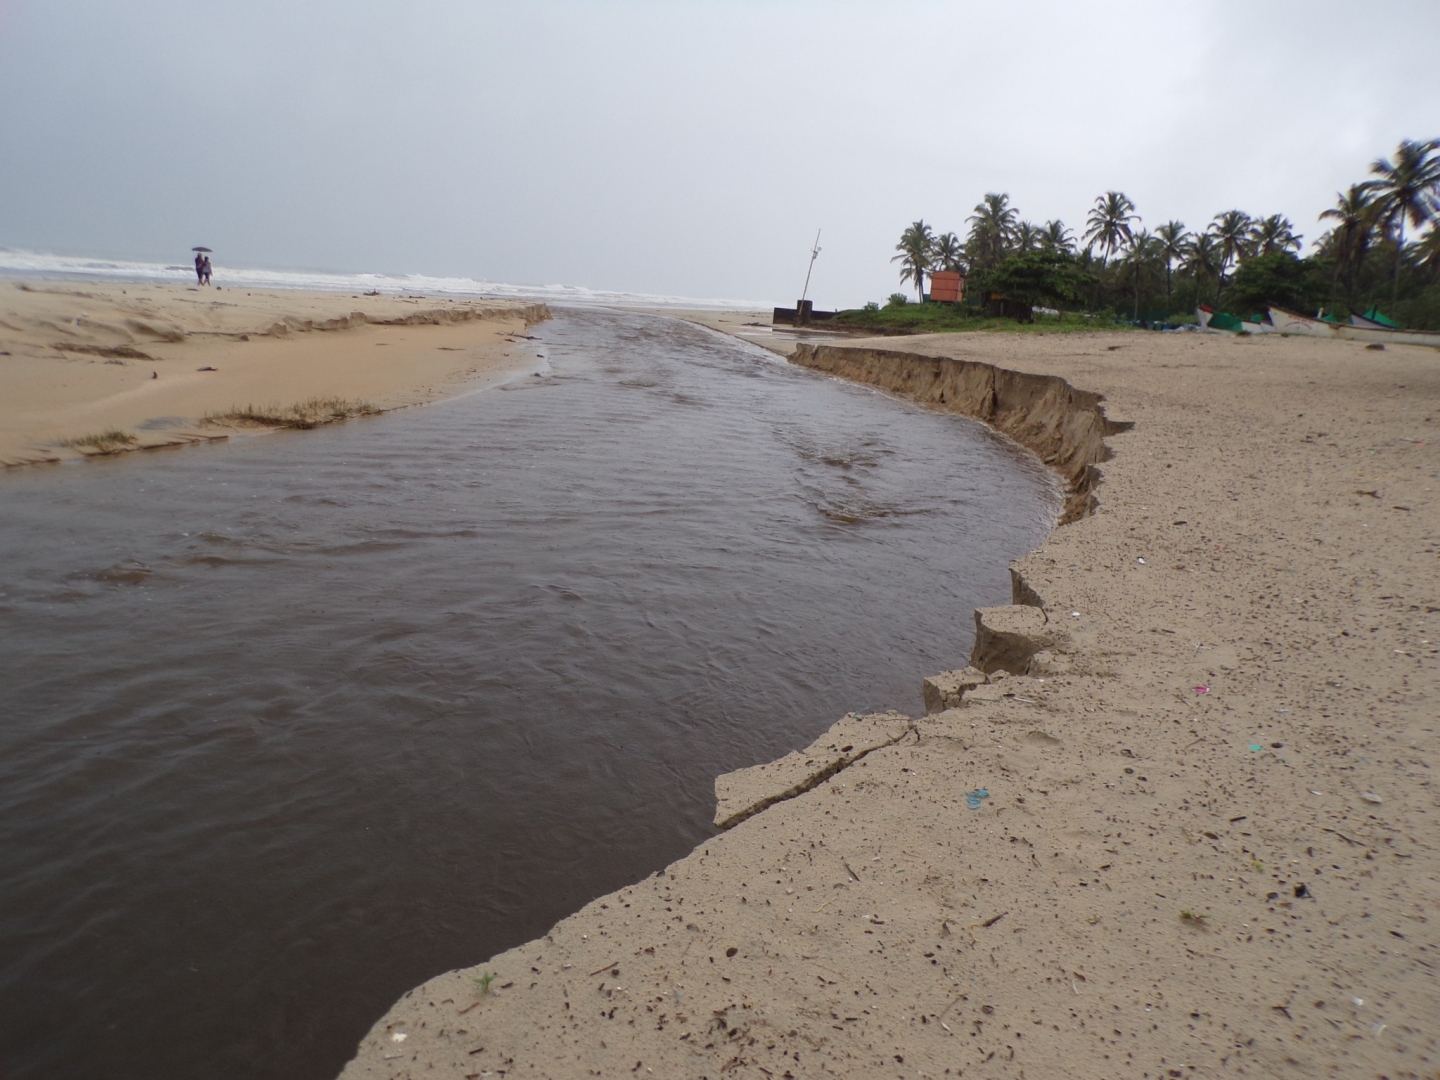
xmin=716 ymin=713 xmax=914 ymax=829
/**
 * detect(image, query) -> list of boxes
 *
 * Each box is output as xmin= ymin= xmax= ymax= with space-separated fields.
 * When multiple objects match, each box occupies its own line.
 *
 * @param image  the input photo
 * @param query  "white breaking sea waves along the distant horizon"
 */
xmin=0 ymin=248 xmax=769 ymax=310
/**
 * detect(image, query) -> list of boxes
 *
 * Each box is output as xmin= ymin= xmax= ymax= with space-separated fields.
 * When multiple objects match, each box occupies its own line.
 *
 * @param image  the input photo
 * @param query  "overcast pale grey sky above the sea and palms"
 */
xmin=0 ymin=0 xmax=1440 ymax=307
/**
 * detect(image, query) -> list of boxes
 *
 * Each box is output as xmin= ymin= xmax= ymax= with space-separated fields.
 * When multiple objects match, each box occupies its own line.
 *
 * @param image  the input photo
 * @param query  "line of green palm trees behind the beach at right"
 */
xmin=891 ymin=140 xmax=1440 ymax=330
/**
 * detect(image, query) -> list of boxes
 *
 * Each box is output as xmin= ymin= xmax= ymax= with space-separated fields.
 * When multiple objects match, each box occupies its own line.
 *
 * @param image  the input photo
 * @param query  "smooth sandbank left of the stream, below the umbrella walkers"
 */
xmin=0 ymin=281 xmax=547 ymax=465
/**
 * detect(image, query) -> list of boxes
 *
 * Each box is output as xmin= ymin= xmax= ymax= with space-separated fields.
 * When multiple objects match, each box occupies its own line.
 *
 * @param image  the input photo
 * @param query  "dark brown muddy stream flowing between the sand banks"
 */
xmin=0 ymin=311 xmax=1057 ymax=1080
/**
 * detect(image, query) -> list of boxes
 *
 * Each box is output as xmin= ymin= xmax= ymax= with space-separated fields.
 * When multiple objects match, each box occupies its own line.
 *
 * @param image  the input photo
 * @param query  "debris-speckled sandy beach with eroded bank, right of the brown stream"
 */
xmin=343 ymin=320 xmax=1440 ymax=1080
